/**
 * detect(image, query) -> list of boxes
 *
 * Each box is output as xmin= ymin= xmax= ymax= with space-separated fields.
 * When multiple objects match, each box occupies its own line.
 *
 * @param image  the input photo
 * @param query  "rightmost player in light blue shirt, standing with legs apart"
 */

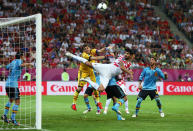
xmin=132 ymin=57 xmax=168 ymax=117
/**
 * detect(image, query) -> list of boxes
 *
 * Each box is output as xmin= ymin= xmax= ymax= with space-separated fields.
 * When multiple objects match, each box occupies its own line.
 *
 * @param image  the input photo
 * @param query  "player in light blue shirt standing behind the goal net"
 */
xmin=1 ymin=52 xmax=32 ymax=126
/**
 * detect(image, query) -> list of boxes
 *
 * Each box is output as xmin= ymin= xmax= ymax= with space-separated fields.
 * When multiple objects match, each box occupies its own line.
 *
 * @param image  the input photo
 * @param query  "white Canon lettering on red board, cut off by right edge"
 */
xmin=166 ymin=85 xmax=193 ymax=92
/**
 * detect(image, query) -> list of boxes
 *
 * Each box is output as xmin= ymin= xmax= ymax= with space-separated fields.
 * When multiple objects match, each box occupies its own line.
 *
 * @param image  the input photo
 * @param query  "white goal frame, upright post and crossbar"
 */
xmin=0 ymin=14 xmax=42 ymax=129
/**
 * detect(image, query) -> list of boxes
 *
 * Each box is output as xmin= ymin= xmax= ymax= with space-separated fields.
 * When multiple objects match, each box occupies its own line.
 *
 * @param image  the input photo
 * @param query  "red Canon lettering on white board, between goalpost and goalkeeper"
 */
xmin=50 ymin=85 xmax=78 ymax=92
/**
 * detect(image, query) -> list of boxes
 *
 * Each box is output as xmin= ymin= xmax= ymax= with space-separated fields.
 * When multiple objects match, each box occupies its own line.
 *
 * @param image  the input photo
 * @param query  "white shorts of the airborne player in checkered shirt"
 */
xmin=92 ymin=63 xmax=122 ymax=89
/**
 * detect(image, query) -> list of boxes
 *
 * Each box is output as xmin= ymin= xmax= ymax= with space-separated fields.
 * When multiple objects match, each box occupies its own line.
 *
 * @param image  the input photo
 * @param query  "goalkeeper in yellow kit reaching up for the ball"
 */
xmin=72 ymin=45 xmax=111 ymax=111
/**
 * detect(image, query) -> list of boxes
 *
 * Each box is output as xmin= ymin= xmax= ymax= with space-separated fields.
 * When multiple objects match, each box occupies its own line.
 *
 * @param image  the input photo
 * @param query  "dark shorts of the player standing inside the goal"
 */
xmin=5 ymin=87 xmax=20 ymax=99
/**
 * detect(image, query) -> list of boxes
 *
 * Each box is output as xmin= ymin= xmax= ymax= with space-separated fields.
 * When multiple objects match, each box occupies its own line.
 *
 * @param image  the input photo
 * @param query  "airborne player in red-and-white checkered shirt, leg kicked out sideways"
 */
xmin=65 ymin=51 xmax=133 ymax=91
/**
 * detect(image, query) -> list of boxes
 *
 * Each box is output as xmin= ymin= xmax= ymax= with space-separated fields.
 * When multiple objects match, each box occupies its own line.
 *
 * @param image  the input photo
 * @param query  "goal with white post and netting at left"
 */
xmin=0 ymin=14 xmax=42 ymax=130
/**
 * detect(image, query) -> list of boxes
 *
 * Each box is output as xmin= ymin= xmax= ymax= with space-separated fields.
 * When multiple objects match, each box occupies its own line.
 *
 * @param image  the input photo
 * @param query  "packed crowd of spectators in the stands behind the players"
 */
xmin=0 ymin=0 xmax=193 ymax=69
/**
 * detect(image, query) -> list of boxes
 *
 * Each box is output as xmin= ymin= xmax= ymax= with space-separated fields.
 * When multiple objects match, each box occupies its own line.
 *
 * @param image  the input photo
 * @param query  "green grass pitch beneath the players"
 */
xmin=0 ymin=96 xmax=193 ymax=131
